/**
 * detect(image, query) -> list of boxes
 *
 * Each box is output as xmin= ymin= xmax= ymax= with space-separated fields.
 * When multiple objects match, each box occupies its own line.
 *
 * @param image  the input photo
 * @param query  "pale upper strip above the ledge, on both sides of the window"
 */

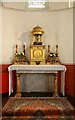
xmin=2 ymin=2 xmax=73 ymax=10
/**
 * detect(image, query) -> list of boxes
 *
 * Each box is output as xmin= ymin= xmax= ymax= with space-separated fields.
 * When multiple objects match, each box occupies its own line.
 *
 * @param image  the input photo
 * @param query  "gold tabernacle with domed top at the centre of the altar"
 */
xmin=30 ymin=25 xmax=45 ymax=64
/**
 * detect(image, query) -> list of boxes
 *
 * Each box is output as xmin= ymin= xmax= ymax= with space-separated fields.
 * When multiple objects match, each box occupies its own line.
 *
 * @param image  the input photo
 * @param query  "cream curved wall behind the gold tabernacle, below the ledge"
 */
xmin=2 ymin=8 xmax=73 ymax=64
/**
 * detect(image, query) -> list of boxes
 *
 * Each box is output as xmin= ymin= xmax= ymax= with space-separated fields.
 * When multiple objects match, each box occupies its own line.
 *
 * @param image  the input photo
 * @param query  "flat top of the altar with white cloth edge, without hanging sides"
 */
xmin=8 ymin=64 xmax=66 ymax=71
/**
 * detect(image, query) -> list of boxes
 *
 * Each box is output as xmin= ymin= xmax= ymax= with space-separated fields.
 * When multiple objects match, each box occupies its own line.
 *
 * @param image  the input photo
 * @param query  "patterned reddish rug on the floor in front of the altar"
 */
xmin=2 ymin=97 xmax=75 ymax=120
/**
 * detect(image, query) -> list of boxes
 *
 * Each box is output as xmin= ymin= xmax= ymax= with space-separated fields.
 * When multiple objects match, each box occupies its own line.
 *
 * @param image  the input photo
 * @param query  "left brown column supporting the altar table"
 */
xmin=15 ymin=73 xmax=21 ymax=97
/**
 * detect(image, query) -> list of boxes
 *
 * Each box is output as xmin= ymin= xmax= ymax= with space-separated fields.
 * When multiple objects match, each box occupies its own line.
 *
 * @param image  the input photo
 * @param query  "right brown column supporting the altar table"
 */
xmin=53 ymin=72 xmax=58 ymax=97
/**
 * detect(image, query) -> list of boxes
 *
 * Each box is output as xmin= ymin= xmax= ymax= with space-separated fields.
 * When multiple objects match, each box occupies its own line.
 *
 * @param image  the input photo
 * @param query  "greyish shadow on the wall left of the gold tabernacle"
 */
xmin=10 ymin=30 xmax=32 ymax=61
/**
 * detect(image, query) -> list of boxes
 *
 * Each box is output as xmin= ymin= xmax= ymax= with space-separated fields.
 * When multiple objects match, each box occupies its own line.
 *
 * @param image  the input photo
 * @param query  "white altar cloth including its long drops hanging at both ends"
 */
xmin=8 ymin=65 xmax=66 ymax=96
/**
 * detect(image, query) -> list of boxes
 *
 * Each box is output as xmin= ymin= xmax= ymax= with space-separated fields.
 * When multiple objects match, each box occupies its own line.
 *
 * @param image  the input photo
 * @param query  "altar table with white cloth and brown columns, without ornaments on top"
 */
xmin=8 ymin=65 xmax=66 ymax=97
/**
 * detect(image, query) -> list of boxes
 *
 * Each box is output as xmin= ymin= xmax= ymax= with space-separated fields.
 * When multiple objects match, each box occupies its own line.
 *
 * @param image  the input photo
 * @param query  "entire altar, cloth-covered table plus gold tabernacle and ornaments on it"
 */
xmin=8 ymin=26 xmax=66 ymax=97
